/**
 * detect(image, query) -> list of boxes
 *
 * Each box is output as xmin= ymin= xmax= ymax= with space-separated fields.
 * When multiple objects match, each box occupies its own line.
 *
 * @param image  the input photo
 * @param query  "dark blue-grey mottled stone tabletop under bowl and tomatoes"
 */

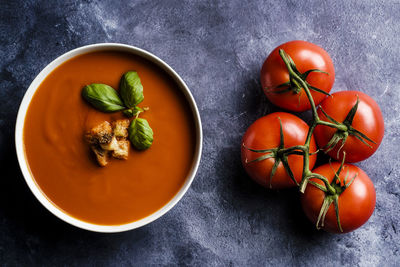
xmin=0 ymin=0 xmax=400 ymax=266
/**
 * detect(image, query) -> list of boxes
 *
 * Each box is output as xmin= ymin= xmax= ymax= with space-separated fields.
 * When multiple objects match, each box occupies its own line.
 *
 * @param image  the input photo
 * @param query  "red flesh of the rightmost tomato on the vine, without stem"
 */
xmin=314 ymin=91 xmax=384 ymax=162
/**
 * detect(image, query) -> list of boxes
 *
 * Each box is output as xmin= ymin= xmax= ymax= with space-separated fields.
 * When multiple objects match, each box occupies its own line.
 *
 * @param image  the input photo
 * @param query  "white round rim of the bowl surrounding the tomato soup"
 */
xmin=15 ymin=43 xmax=203 ymax=233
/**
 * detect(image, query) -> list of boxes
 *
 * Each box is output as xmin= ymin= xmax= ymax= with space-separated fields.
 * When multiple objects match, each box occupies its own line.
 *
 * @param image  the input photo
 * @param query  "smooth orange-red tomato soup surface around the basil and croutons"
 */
xmin=24 ymin=51 xmax=195 ymax=225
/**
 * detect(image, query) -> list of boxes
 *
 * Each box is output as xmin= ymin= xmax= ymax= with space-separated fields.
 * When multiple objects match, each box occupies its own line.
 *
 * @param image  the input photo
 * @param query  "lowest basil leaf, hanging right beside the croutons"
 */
xmin=129 ymin=118 xmax=153 ymax=150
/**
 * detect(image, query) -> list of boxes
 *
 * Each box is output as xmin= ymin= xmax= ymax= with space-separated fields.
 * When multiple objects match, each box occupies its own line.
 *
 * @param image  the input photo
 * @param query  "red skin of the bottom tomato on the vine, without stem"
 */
xmin=301 ymin=162 xmax=376 ymax=233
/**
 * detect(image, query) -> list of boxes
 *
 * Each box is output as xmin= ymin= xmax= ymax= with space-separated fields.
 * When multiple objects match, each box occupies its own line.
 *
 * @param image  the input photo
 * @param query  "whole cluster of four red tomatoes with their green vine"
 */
xmin=242 ymin=41 xmax=384 ymax=233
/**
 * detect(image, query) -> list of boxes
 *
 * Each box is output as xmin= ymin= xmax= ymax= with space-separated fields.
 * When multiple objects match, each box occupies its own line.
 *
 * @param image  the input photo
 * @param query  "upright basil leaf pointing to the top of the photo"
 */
xmin=119 ymin=71 xmax=144 ymax=108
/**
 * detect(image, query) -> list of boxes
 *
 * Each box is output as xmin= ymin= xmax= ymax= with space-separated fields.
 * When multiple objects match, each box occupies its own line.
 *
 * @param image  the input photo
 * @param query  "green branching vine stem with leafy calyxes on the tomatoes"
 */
xmin=243 ymin=49 xmax=374 ymax=232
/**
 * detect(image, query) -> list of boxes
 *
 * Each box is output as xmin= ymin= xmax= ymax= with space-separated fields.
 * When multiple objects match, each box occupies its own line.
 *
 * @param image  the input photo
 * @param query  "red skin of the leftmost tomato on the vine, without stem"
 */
xmin=242 ymin=112 xmax=316 ymax=189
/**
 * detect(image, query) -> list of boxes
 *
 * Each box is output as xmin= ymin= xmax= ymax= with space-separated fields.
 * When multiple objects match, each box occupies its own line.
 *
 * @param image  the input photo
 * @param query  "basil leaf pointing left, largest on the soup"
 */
xmin=82 ymin=83 xmax=125 ymax=112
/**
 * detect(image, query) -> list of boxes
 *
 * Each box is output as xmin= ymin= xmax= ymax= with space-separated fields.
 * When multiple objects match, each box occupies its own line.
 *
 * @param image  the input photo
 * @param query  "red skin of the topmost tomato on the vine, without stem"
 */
xmin=261 ymin=41 xmax=335 ymax=112
